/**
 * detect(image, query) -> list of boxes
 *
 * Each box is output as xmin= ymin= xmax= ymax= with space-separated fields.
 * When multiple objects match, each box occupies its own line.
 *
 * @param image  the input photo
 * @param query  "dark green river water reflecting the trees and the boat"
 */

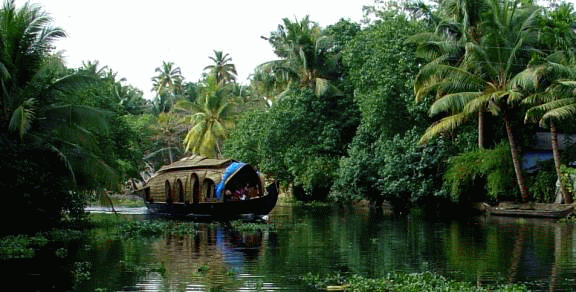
xmin=9 ymin=205 xmax=576 ymax=291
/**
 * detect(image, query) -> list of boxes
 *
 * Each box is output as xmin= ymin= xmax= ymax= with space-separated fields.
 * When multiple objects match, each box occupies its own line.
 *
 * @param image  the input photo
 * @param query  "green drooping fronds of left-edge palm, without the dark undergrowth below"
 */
xmin=0 ymin=1 xmax=118 ymax=191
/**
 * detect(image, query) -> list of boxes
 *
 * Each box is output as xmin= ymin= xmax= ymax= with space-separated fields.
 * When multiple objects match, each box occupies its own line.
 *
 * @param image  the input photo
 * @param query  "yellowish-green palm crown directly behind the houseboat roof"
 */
xmin=175 ymin=76 xmax=235 ymax=157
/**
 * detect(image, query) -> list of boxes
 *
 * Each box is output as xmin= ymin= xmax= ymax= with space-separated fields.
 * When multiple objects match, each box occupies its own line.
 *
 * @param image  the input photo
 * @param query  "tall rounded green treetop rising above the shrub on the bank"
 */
xmin=342 ymin=12 xmax=426 ymax=139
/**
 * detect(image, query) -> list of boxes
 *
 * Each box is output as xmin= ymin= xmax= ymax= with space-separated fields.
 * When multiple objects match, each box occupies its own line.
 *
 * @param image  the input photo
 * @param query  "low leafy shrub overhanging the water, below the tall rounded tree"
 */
xmin=334 ymin=129 xmax=456 ymax=210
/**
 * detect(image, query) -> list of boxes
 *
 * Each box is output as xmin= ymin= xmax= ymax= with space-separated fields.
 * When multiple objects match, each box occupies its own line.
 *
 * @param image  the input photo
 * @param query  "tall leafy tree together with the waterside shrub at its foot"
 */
xmin=334 ymin=12 xmax=450 ymax=208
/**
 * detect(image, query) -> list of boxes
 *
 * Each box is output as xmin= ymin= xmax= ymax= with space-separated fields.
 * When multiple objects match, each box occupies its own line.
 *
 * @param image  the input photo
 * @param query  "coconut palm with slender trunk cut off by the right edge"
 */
xmin=520 ymin=3 xmax=576 ymax=203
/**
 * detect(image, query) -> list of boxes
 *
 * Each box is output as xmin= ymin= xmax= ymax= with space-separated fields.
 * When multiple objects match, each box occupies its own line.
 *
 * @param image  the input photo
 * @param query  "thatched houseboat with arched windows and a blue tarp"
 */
xmin=139 ymin=156 xmax=278 ymax=217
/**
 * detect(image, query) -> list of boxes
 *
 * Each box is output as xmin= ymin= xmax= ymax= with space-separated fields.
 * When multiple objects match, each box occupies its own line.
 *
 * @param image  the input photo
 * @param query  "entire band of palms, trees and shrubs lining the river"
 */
xmin=5 ymin=0 xmax=576 ymax=233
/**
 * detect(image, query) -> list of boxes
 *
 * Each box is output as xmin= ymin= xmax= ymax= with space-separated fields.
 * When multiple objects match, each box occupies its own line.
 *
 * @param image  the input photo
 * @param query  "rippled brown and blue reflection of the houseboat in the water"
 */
xmin=132 ymin=223 xmax=284 ymax=291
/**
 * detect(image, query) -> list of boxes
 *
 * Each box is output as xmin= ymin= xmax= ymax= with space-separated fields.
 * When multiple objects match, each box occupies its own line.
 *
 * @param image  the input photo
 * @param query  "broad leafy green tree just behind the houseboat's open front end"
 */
xmin=224 ymin=89 xmax=358 ymax=200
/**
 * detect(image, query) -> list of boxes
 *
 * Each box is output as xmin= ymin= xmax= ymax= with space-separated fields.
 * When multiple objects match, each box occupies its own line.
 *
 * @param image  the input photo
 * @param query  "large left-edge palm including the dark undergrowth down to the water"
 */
xmin=0 ymin=1 xmax=138 ymax=229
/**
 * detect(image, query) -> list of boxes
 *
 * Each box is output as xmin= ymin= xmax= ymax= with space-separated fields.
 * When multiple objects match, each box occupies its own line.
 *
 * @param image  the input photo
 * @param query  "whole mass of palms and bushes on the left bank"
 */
xmin=0 ymin=1 xmax=151 ymax=234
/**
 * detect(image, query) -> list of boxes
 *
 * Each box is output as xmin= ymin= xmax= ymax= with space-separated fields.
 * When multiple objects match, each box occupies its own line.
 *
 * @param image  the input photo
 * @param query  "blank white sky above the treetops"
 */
xmin=28 ymin=0 xmax=374 ymax=98
